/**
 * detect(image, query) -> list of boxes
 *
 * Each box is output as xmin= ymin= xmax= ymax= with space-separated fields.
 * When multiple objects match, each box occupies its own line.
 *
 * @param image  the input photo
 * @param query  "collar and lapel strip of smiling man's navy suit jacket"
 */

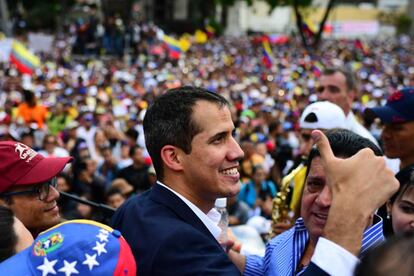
xmin=150 ymin=184 xmax=218 ymax=244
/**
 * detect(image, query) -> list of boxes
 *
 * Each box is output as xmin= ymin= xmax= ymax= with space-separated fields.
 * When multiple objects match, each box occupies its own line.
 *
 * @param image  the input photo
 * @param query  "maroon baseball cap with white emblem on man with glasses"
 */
xmin=0 ymin=141 xmax=73 ymax=193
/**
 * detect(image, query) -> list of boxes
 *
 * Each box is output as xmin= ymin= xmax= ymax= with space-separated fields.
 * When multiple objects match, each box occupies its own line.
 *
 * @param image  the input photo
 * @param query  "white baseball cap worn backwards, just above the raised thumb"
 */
xmin=300 ymin=101 xmax=347 ymax=129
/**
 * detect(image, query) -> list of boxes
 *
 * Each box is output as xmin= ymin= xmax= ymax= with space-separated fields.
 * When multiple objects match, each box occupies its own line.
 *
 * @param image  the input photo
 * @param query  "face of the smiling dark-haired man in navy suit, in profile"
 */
xmin=181 ymin=101 xmax=243 ymax=202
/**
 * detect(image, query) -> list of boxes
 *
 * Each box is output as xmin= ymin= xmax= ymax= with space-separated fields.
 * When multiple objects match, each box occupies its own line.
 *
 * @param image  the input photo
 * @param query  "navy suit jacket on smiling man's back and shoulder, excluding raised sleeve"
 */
xmin=114 ymin=185 xmax=240 ymax=275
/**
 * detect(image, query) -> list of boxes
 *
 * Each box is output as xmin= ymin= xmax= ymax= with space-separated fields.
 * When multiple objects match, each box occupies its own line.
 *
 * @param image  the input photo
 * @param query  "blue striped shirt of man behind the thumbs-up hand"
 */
xmin=244 ymin=215 xmax=385 ymax=276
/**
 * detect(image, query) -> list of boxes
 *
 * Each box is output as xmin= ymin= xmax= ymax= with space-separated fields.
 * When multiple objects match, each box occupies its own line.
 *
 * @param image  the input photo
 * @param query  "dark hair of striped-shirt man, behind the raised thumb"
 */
xmin=306 ymin=128 xmax=383 ymax=176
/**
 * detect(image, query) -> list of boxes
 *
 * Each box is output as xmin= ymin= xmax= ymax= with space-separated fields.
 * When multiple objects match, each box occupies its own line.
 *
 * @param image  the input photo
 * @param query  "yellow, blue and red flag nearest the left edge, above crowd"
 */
xmin=10 ymin=40 xmax=40 ymax=75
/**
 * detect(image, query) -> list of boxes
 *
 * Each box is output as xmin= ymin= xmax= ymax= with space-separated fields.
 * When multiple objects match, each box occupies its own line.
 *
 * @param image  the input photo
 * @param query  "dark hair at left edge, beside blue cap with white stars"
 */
xmin=0 ymin=205 xmax=17 ymax=263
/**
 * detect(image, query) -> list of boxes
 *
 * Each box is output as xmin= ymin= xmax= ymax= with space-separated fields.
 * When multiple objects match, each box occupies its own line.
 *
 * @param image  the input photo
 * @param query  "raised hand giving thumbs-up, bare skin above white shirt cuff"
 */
xmin=312 ymin=130 xmax=399 ymax=255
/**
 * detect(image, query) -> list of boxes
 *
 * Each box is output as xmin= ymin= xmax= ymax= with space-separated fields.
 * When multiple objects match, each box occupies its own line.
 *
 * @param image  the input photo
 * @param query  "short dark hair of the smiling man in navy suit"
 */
xmin=143 ymin=86 xmax=229 ymax=180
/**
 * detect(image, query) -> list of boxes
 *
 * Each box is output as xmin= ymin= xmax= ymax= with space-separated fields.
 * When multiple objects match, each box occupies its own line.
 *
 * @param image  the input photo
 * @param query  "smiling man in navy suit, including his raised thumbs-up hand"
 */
xmin=112 ymin=87 xmax=398 ymax=275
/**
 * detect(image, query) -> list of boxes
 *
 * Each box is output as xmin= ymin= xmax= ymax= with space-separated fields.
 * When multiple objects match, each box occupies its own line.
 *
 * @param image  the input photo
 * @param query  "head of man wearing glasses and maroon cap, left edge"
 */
xmin=0 ymin=141 xmax=72 ymax=237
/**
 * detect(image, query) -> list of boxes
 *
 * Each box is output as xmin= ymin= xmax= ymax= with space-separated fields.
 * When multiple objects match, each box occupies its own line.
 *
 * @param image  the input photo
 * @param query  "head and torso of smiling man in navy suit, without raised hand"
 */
xmin=113 ymin=87 xmax=243 ymax=275
